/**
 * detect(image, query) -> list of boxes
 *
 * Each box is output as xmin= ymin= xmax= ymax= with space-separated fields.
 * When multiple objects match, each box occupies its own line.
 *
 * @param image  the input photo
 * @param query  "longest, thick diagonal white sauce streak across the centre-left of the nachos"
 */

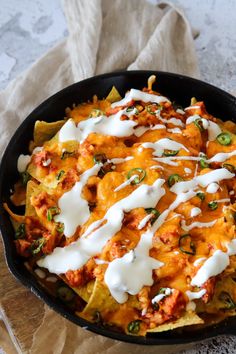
xmin=38 ymin=179 xmax=165 ymax=276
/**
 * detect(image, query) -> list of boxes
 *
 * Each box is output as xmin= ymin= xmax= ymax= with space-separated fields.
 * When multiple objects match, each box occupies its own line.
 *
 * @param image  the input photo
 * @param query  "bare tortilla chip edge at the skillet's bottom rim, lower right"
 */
xmin=147 ymin=312 xmax=204 ymax=333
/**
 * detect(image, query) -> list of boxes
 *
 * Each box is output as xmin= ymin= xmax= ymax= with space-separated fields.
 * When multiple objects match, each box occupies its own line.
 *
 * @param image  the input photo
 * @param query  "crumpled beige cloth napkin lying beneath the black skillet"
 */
xmin=0 ymin=0 xmax=199 ymax=354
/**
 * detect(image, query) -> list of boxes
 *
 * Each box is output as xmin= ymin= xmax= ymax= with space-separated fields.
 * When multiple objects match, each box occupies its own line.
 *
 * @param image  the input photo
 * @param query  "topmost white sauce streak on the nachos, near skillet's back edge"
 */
xmin=111 ymin=89 xmax=170 ymax=108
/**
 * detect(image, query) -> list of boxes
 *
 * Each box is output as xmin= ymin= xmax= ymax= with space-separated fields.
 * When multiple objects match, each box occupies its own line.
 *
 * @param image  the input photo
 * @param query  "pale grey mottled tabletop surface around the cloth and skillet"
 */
xmin=0 ymin=0 xmax=236 ymax=354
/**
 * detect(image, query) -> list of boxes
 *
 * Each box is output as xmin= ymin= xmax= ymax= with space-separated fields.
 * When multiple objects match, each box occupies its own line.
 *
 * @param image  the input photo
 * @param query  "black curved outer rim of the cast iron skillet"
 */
xmin=0 ymin=70 xmax=236 ymax=345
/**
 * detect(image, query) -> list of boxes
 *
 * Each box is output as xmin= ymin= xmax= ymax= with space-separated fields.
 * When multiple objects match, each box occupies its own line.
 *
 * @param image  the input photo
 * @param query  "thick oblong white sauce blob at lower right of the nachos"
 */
xmin=191 ymin=250 xmax=229 ymax=287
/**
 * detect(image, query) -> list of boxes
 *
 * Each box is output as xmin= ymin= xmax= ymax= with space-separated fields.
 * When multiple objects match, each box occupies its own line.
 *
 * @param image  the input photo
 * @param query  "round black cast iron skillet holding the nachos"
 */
xmin=0 ymin=71 xmax=236 ymax=345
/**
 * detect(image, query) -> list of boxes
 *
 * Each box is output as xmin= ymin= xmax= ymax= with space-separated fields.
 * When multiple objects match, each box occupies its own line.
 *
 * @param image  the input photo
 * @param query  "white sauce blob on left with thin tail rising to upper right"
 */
xmin=54 ymin=164 xmax=102 ymax=237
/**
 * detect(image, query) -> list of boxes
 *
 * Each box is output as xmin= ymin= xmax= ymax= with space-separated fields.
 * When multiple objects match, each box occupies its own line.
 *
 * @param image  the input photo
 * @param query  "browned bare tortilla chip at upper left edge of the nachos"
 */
xmin=34 ymin=120 xmax=65 ymax=146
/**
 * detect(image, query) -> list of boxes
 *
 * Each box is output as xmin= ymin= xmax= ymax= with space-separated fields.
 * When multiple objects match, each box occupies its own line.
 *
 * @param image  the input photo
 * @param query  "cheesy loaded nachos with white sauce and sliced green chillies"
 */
xmin=5 ymin=76 xmax=236 ymax=335
